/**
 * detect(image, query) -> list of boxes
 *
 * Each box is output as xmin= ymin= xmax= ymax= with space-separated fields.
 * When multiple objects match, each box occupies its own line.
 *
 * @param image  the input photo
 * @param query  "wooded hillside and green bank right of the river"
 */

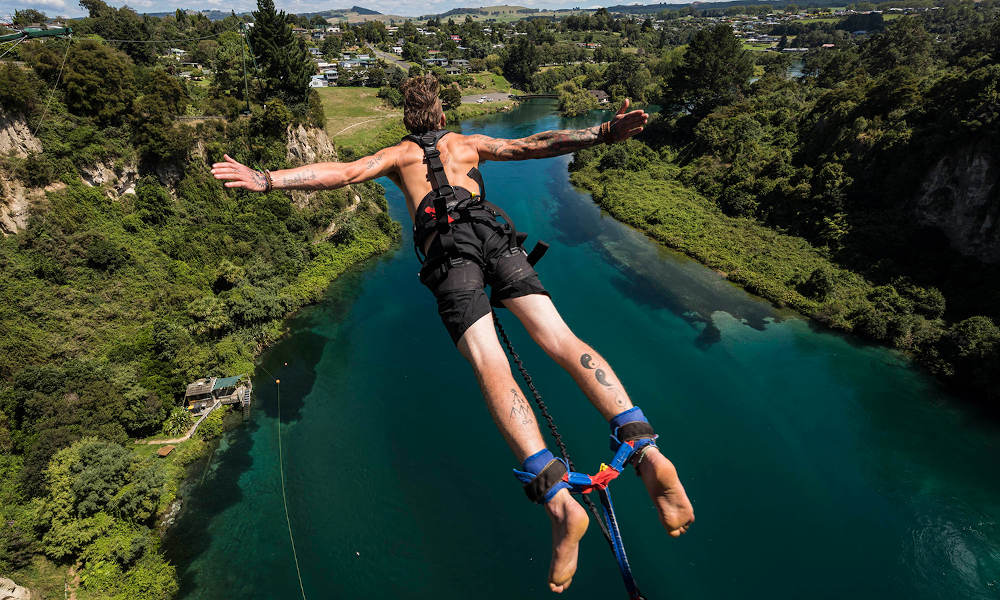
xmin=573 ymin=2 xmax=1000 ymax=402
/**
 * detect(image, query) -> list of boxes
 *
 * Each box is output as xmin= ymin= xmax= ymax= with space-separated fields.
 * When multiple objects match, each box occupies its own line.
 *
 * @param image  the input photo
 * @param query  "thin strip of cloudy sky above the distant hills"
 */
xmin=0 ymin=0 xmax=683 ymax=21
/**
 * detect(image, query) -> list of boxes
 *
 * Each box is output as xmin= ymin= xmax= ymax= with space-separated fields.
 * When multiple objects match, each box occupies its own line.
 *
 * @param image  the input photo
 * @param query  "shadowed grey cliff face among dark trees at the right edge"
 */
xmin=913 ymin=141 xmax=1000 ymax=263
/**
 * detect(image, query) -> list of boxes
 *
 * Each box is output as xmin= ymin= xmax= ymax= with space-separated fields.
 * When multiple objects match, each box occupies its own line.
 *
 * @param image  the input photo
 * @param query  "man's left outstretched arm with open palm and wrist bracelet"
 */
xmin=212 ymin=146 xmax=396 ymax=192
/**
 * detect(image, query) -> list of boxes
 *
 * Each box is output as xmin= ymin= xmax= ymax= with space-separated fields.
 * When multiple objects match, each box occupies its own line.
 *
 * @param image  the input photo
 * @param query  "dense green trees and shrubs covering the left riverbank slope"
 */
xmin=0 ymin=0 xmax=399 ymax=599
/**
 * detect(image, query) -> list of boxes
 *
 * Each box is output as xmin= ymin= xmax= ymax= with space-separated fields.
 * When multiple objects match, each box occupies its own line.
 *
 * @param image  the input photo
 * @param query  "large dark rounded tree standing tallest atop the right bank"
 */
xmin=667 ymin=23 xmax=753 ymax=119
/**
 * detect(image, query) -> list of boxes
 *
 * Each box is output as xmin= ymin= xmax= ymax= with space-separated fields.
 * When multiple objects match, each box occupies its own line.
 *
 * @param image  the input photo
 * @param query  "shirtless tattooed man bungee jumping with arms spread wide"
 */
xmin=212 ymin=75 xmax=694 ymax=592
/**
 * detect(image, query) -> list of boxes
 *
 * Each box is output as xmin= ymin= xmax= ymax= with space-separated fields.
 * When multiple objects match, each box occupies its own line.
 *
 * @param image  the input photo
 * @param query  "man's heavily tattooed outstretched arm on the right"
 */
xmin=470 ymin=98 xmax=649 ymax=160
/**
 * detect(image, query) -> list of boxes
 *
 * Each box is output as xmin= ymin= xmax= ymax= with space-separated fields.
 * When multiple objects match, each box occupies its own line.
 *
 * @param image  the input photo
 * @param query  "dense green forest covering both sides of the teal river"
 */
xmin=0 ymin=0 xmax=1000 ymax=599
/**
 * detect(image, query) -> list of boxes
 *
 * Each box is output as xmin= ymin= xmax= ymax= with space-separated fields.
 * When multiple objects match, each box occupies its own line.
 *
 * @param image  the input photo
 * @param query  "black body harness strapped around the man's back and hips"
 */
xmin=403 ymin=129 xmax=549 ymax=267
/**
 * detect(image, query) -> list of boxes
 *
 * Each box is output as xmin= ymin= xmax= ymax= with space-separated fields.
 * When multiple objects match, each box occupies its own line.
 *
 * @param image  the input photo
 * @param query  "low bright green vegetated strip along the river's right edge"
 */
xmin=570 ymin=140 xmax=996 ymax=401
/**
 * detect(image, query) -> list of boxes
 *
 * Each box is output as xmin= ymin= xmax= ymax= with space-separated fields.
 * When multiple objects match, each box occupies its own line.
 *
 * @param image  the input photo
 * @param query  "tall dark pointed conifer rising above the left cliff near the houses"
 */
xmin=249 ymin=0 xmax=314 ymax=106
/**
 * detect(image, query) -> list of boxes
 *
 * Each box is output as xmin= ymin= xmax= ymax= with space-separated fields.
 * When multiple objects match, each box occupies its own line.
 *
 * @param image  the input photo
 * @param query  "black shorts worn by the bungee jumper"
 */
xmin=420 ymin=221 xmax=549 ymax=344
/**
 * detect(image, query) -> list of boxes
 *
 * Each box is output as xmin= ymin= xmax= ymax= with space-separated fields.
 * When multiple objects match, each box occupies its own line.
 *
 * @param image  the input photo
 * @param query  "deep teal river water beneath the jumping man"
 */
xmin=165 ymin=102 xmax=1000 ymax=600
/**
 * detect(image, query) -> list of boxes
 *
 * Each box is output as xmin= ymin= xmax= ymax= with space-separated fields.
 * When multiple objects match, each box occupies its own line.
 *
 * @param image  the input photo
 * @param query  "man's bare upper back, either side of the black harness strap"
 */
xmin=388 ymin=133 xmax=482 ymax=219
